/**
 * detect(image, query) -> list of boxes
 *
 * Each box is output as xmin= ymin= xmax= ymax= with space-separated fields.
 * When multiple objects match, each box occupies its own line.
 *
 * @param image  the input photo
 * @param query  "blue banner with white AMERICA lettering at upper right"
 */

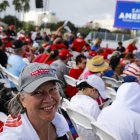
xmin=114 ymin=1 xmax=140 ymax=29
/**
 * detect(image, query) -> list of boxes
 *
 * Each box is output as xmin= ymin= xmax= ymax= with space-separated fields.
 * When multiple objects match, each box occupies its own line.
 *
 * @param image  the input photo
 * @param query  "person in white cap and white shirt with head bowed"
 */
xmin=70 ymin=75 xmax=106 ymax=140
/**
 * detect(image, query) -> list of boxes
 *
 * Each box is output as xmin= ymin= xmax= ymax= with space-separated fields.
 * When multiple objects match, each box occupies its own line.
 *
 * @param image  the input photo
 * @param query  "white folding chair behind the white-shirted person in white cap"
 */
xmin=66 ymin=106 xmax=98 ymax=140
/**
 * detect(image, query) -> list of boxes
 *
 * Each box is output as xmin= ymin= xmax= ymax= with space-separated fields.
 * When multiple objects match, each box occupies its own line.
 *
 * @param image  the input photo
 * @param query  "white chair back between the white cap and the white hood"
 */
xmin=102 ymin=76 xmax=122 ymax=88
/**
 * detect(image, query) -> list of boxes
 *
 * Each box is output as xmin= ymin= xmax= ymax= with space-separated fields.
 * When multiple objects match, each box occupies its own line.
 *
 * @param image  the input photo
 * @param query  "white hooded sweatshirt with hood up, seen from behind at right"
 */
xmin=97 ymin=82 xmax=140 ymax=140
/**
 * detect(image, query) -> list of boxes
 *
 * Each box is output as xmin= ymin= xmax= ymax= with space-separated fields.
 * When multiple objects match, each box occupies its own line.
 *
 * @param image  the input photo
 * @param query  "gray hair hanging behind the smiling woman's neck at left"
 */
xmin=8 ymin=93 xmax=26 ymax=118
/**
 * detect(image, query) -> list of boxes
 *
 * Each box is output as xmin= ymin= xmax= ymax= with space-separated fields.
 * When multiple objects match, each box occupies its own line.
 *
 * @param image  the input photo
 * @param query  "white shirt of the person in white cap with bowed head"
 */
xmin=70 ymin=93 xmax=100 ymax=140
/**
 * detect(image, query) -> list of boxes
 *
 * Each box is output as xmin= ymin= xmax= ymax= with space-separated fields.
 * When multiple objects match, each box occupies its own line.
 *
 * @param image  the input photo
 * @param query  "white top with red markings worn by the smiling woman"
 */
xmin=0 ymin=113 xmax=69 ymax=140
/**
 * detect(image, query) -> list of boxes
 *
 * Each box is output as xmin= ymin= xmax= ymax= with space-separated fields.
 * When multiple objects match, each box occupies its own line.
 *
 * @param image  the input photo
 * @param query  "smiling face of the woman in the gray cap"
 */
xmin=20 ymin=81 xmax=60 ymax=122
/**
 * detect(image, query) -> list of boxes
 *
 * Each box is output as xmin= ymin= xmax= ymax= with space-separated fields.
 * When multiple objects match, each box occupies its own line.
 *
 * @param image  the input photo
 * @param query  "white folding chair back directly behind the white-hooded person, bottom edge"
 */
xmin=91 ymin=121 xmax=117 ymax=140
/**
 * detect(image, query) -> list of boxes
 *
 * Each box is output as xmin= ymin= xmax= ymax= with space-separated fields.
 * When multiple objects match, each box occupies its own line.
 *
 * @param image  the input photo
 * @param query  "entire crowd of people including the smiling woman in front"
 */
xmin=0 ymin=25 xmax=140 ymax=140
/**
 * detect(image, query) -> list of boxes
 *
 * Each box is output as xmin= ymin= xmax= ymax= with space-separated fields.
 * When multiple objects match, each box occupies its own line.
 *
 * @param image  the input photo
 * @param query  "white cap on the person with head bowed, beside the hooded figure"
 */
xmin=77 ymin=74 xmax=106 ymax=99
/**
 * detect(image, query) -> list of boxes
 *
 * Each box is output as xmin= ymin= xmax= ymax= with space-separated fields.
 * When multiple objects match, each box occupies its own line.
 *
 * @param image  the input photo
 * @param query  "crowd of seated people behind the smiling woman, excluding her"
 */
xmin=0 ymin=22 xmax=140 ymax=140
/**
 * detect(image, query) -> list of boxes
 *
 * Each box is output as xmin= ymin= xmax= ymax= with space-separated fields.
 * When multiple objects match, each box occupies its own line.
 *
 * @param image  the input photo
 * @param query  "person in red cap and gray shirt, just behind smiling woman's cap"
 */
xmin=51 ymin=49 xmax=72 ymax=84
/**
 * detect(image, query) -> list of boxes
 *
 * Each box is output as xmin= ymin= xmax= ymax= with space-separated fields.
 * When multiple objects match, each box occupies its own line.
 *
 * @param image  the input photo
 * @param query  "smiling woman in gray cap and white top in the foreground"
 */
xmin=0 ymin=63 xmax=73 ymax=140
